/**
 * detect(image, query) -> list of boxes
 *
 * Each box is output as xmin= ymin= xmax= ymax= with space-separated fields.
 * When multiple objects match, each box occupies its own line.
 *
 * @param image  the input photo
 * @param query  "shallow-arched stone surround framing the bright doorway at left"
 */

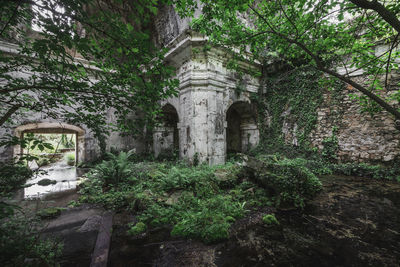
xmin=14 ymin=122 xmax=85 ymax=165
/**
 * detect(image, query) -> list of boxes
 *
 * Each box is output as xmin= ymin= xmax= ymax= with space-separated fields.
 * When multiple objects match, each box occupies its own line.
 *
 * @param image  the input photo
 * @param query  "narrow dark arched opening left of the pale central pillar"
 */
xmin=153 ymin=104 xmax=179 ymax=158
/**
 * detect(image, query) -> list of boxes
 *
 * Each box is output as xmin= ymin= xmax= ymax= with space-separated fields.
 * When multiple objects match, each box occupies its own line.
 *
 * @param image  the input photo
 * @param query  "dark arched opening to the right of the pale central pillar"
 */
xmin=226 ymin=101 xmax=259 ymax=155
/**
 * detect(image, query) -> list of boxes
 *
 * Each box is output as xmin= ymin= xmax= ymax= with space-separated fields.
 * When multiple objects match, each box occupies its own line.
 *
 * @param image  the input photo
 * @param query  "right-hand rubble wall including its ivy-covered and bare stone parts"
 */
xmin=254 ymin=68 xmax=400 ymax=162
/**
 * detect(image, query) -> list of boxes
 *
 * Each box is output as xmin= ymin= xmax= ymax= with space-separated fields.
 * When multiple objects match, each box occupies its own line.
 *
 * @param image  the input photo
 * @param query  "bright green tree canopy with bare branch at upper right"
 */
xmin=177 ymin=0 xmax=400 ymax=126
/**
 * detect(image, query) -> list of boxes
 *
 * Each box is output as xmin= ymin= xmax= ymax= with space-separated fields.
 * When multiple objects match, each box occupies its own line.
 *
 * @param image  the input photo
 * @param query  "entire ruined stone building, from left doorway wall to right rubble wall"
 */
xmin=0 ymin=6 xmax=400 ymax=164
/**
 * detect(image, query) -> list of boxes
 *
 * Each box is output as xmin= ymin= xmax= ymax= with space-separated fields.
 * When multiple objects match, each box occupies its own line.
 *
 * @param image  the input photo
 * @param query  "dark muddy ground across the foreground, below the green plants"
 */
xmin=109 ymin=176 xmax=400 ymax=266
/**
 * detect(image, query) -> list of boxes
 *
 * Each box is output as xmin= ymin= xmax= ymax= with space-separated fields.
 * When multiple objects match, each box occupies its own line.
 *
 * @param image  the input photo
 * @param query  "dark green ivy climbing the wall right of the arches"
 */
xmin=253 ymin=67 xmax=344 ymax=158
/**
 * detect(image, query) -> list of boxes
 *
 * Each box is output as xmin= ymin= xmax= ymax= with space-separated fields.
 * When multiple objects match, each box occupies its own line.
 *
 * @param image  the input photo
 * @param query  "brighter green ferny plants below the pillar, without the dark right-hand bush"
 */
xmin=80 ymin=157 xmax=272 ymax=243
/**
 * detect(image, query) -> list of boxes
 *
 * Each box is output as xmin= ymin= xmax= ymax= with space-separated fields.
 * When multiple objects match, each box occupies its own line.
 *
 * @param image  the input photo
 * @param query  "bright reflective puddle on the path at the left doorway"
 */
xmin=24 ymin=162 xmax=78 ymax=199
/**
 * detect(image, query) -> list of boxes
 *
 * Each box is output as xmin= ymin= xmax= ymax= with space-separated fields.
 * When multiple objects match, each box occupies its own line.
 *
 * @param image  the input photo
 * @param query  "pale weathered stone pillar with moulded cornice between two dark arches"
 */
xmin=153 ymin=30 xmax=259 ymax=164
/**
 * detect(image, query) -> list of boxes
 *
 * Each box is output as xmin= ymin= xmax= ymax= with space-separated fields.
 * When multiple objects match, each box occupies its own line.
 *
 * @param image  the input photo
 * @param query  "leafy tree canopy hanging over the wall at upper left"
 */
xmin=0 ymin=0 xmax=177 ymax=144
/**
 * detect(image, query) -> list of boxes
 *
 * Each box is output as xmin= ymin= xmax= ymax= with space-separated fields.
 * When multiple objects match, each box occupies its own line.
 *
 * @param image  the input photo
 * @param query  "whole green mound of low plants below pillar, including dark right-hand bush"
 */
xmin=80 ymin=152 xmax=321 ymax=243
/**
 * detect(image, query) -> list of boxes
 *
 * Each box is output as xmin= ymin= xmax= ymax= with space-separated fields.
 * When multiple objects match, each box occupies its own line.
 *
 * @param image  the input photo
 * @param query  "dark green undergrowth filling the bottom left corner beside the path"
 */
xmin=0 ymin=163 xmax=62 ymax=266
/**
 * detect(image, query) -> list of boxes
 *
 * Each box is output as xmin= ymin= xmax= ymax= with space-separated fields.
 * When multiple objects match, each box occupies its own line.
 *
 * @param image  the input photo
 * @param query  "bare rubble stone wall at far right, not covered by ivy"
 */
xmin=311 ymin=84 xmax=400 ymax=162
